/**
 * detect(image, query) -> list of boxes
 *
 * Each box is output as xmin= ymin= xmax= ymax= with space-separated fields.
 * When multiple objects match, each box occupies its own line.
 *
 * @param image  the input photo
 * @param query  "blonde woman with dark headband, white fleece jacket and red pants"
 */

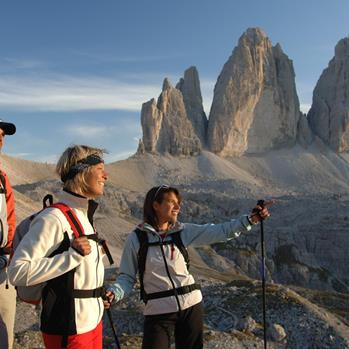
xmin=9 ymin=145 xmax=107 ymax=349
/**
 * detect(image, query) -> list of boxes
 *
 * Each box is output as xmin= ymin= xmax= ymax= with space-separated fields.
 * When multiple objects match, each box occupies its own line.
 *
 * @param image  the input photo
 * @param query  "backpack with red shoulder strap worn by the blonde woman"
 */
xmin=13 ymin=194 xmax=95 ymax=304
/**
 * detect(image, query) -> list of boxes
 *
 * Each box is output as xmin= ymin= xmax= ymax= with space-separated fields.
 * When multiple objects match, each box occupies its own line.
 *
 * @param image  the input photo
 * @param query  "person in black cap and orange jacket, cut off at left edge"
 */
xmin=0 ymin=120 xmax=16 ymax=349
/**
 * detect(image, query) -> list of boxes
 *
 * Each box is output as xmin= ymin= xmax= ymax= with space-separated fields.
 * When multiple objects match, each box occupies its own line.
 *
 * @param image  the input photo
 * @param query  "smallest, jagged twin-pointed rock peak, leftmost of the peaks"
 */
xmin=138 ymin=72 xmax=207 ymax=155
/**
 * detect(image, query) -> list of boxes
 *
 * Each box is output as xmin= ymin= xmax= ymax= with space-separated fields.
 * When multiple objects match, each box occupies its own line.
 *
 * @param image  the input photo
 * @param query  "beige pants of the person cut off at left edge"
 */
xmin=0 ymin=269 xmax=16 ymax=349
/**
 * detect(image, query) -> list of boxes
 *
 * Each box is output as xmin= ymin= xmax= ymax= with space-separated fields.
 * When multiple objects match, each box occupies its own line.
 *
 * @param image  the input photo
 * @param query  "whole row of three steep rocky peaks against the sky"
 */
xmin=137 ymin=28 xmax=349 ymax=156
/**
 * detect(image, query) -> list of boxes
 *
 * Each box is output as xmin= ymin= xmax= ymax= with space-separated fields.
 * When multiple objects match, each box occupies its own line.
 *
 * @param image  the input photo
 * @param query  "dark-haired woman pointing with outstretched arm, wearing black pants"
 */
xmin=107 ymin=185 xmax=271 ymax=349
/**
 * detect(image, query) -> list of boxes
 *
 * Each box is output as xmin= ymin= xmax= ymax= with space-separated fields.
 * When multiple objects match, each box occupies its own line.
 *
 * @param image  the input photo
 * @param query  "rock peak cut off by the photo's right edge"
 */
xmin=308 ymin=38 xmax=349 ymax=152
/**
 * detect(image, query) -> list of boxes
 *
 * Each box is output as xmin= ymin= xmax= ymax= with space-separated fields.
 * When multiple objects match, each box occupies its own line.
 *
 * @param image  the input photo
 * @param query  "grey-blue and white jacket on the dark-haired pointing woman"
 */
xmin=109 ymin=216 xmax=251 ymax=315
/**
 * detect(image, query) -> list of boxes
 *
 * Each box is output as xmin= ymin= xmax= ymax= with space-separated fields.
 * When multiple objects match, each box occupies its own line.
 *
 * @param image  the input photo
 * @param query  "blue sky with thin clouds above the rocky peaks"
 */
xmin=0 ymin=0 xmax=349 ymax=162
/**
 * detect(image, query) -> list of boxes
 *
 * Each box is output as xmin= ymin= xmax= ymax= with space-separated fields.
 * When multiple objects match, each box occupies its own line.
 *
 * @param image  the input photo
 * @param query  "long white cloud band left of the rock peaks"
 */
xmin=0 ymin=75 xmax=160 ymax=111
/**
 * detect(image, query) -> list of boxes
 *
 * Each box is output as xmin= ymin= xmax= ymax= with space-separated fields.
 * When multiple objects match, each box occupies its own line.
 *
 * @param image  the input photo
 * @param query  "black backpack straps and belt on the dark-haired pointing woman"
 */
xmin=135 ymin=228 xmax=192 ymax=303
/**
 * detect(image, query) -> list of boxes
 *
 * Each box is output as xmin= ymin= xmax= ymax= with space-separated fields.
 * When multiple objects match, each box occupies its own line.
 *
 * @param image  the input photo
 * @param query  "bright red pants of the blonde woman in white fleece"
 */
xmin=42 ymin=321 xmax=102 ymax=349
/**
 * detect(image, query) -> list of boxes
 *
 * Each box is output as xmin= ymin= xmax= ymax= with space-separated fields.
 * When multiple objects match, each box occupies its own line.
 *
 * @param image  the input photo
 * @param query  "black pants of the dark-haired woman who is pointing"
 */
xmin=142 ymin=303 xmax=203 ymax=349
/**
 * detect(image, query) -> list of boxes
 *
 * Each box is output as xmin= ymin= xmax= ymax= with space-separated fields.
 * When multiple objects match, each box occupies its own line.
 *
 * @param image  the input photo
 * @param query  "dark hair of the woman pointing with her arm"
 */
xmin=143 ymin=185 xmax=182 ymax=229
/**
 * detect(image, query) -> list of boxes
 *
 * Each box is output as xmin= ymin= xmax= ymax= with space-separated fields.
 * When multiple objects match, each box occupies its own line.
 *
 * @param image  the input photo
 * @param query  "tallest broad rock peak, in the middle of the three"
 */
xmin=208 ymin=29 xmax=300 ymax=155
